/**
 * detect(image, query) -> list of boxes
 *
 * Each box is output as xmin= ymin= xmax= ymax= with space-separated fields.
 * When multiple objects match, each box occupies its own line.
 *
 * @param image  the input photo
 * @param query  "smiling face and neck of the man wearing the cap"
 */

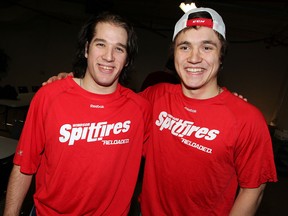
xmin=174 ymin=27 xmax=221 ymax=99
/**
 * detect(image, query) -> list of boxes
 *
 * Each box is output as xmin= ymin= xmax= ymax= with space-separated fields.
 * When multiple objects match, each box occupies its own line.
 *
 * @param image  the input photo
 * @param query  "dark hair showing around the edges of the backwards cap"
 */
xmin=170 ymin=11 xmax=228 ymax=70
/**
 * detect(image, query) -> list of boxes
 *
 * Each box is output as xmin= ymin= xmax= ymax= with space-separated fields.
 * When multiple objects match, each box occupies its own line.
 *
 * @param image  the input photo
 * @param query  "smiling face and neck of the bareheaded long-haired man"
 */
xmin=83 ymin=22 xmax=128 ymax=94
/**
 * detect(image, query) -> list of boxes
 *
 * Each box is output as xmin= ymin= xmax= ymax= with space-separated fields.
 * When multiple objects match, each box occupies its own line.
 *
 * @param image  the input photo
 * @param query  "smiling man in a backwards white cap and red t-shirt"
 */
xmin=140 ymin=8 xmax=277 ymax=216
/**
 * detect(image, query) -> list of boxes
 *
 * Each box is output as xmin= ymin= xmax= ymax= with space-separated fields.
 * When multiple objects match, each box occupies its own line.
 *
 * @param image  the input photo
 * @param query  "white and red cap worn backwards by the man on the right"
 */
xmin=173 ymin=7 xmax=226 ymax=41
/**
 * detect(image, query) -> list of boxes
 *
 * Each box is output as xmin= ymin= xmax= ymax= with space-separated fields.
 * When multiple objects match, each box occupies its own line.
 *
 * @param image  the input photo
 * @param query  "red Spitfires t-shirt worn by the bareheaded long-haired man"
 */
xmin=14 ymin=77 xmax=151 ymax=215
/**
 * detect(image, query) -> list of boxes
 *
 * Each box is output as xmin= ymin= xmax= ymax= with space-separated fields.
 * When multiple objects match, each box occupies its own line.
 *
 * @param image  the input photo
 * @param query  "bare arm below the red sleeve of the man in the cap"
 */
xmin=229 ymin=184 xmax=266 ymax=216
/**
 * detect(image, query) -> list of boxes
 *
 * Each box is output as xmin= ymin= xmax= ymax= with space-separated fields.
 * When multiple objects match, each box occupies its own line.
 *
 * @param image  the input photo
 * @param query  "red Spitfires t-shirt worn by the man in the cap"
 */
xmin=140 ymin=84 xmax=277 ymax=216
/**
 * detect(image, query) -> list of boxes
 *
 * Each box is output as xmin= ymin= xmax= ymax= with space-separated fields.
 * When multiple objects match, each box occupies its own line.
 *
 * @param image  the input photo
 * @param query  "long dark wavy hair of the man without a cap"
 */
xmin=73 ymin=12 xmax=138 ymax=84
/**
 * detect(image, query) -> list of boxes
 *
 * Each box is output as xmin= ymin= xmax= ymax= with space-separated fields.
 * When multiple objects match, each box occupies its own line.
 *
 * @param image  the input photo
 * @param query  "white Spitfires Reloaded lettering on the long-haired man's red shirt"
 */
xmin=59 ymin=120 xmax=131 ymax=145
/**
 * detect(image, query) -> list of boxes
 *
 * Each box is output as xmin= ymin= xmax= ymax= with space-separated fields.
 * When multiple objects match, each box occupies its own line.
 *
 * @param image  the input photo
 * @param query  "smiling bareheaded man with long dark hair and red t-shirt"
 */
xmin=4 ymin=13 xmax=151 ymax=216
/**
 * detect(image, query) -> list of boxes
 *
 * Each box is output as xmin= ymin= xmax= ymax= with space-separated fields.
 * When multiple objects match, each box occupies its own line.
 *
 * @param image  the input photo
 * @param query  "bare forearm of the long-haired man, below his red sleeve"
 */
xmin=4 ymin=165 xmax=33 ymax=216
